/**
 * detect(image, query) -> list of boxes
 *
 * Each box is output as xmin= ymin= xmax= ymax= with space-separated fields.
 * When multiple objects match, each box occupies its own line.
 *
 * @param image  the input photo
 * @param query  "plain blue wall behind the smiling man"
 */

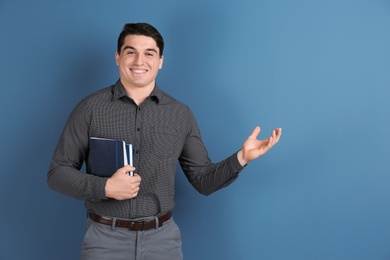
xmin=0 ymin=0 xmax=390 ymax=260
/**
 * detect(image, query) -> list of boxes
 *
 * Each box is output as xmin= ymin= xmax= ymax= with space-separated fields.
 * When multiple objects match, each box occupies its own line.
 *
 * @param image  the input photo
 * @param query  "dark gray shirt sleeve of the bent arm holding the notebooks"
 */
xmin=47 ymin=100 xmax=107 ymax=201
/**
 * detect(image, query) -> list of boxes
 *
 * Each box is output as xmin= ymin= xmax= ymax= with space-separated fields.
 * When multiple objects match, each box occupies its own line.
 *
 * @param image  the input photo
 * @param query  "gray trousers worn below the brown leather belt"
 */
xmin=80 ymin=218 xmax=183 ymax=260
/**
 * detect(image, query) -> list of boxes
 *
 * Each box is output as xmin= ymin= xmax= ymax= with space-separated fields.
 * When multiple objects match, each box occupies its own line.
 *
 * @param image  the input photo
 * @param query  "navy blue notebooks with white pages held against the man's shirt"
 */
xmin=89 ymin=137 xmax=133 ymax=177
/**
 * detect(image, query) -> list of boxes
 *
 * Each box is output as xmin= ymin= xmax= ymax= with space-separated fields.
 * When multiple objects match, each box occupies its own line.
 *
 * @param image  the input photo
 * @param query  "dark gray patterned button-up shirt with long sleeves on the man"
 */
xmin=48 ymin=80 xmax=243 ymax=218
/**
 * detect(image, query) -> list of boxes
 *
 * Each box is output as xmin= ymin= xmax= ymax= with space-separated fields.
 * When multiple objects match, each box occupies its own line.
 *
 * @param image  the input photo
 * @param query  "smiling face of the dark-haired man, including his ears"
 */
xmin=115 ymin=35 xmax=164 ymax=89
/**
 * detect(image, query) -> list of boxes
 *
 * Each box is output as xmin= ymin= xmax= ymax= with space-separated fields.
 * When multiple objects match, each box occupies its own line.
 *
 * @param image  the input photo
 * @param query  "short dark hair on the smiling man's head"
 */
xmin=118 ymin=23 xmax=164 ymax=56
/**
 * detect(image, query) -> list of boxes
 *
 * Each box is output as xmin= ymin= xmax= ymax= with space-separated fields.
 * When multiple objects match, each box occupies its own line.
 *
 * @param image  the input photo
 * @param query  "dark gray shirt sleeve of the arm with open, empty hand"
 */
xmin=179 ymin=107 xmax=244 ymax=195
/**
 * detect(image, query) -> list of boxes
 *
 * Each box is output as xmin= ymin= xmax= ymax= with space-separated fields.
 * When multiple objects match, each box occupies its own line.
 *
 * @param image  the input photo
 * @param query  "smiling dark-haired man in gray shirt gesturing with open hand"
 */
xmin=48 ymin=23 xmax=282 ymax=260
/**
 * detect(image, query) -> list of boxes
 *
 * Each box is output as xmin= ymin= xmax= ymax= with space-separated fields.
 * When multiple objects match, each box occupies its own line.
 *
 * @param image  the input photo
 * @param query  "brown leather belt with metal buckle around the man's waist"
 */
xmin=88 ymin=211 xmax=172 ymax=231
